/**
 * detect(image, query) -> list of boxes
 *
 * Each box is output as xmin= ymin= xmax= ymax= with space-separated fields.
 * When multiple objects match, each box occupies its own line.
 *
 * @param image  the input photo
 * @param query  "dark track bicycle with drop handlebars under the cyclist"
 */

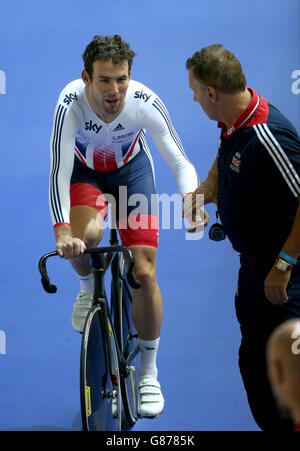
xmin=38 ymin=229 xmax=141 ymax=431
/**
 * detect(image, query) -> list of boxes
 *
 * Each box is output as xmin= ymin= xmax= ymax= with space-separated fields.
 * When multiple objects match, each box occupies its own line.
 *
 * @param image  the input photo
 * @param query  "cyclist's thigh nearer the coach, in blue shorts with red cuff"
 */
xmin=112 ymin=150 xmax=159 ymax=249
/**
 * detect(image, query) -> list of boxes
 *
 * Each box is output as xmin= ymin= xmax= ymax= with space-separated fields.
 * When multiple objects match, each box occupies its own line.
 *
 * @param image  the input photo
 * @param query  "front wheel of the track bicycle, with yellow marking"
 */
xmin=80 ymin=305 xmax=121 ymax=431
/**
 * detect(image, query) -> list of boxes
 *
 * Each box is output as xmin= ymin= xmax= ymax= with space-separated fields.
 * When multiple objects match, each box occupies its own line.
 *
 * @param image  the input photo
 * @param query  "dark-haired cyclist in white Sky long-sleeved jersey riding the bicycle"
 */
xmin=49 ymin=35 xmax=203 ymax=417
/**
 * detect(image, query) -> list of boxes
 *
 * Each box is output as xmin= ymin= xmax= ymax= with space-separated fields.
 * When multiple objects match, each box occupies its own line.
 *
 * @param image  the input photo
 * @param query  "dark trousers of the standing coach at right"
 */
xmin=235 ymin=258 xmax=300 ymax=431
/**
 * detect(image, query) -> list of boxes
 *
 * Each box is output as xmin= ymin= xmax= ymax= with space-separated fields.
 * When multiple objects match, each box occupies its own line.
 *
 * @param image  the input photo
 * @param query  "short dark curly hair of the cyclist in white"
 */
xmin=82 ymin=34 xmax=136 ymax=78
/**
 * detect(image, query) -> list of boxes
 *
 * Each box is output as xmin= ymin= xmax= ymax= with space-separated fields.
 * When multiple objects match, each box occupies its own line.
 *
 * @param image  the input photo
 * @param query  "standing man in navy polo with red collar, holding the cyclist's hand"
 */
xmin=186 ymin=45 xmax=300 ymax=431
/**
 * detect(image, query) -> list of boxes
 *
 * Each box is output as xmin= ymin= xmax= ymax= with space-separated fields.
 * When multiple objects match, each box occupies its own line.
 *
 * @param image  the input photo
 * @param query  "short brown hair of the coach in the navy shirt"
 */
xmin=186 ymin=44 xmax=246 ymax=94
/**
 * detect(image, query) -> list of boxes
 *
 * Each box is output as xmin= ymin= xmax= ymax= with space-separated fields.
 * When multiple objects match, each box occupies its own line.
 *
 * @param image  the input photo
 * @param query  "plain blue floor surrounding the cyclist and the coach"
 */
xmin=0 ymin=0 xmax=300 ymax=431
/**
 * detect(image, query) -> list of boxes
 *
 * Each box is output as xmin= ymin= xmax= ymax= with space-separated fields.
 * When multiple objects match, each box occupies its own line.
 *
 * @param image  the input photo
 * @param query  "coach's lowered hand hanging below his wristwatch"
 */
xmin=264 ymin=266 xmax=291 ymax=305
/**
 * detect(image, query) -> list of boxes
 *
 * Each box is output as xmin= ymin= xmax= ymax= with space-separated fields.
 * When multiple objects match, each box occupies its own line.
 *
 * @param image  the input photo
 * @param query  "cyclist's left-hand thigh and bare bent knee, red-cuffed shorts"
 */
xmin=70 ymin=158 xmax=107 ymax=243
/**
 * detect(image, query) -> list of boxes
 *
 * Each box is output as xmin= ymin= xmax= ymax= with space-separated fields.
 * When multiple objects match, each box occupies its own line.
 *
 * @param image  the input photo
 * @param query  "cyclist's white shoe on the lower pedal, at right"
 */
xmin=138 ymin=376 xmax=165 ymax=418
